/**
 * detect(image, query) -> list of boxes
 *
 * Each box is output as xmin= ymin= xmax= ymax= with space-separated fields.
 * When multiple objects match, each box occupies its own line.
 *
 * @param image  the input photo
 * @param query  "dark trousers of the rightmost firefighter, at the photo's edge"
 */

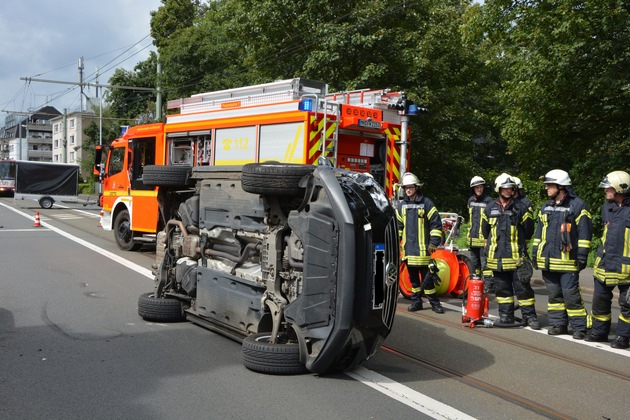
xmin=591 ymin=279 xmax=630 ymax=338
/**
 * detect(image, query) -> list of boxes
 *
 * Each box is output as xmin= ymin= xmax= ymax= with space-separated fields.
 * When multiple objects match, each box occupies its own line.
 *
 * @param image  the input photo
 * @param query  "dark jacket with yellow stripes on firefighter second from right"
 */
xmin=532 ymin=195 xmax=593 ymax=272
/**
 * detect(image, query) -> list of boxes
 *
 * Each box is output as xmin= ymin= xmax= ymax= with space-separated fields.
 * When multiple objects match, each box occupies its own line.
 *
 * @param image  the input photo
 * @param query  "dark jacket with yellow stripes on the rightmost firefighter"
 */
xmin=593 ymin=197 xmax=630 ymax=286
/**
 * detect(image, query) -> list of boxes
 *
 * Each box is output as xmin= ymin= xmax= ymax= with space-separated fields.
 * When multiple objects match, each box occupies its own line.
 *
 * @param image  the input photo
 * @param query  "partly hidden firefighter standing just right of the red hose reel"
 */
xmin=466 ymin=176 xmax=494 ymax=293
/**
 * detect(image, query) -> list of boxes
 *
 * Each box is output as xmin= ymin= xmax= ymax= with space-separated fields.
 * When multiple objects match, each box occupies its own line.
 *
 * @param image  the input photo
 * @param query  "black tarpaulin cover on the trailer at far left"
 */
xmin=15 ymin=162 xmax=79 ymax=196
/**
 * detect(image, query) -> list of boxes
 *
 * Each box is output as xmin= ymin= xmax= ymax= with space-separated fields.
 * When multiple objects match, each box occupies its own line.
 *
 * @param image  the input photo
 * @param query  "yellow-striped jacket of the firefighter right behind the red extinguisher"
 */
xmin=481 ymin=199 xmax=526 ymax=271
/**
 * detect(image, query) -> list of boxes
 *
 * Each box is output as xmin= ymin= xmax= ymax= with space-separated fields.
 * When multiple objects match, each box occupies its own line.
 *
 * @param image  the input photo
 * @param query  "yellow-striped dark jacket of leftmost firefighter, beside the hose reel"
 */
xmin=396 ymin=194 xmax=442 ymax=265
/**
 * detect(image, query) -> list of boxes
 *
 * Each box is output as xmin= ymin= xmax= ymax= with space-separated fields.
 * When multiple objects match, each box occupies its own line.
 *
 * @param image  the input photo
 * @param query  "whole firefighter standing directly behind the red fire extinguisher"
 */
xmin=481 ymin=173 xmax=540 ymax=330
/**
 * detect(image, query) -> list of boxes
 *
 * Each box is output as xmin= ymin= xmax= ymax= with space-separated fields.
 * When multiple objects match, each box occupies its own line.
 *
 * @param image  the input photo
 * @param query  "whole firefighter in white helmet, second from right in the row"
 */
xmin=532 ymin=169 xmax=593 ymax=340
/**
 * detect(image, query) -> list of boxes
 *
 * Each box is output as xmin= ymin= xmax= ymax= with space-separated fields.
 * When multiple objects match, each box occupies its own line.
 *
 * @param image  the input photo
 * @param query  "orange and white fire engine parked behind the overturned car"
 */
xmin=95 ymin=78 xmax=417 ymax=250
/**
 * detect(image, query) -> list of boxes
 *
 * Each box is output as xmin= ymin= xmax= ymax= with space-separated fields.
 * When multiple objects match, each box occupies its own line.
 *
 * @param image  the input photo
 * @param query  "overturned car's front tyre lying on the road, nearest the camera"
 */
xmin=243 ymin=333 xmax=306 ymax=375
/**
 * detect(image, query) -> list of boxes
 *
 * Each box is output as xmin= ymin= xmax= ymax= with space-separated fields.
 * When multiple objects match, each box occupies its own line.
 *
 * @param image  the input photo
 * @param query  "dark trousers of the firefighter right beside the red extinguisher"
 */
xmin=493 ymin=271 xmax=536 ymax=320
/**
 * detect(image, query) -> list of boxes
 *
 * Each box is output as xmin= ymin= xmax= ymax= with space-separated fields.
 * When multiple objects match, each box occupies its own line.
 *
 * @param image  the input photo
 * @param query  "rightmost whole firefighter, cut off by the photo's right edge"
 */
xmin=586 ymin=171 xmax=630 ymax=349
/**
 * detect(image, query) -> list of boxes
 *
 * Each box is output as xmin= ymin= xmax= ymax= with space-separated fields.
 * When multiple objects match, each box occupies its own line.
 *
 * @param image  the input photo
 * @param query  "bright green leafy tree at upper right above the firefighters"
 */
xmin=483 ymin=0 xmax=630 ymax=192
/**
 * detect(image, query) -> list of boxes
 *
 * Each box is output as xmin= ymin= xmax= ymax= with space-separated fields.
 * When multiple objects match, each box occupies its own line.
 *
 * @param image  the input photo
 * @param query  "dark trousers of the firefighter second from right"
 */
xmin=542 ymin=270 xmax=587 ymax=332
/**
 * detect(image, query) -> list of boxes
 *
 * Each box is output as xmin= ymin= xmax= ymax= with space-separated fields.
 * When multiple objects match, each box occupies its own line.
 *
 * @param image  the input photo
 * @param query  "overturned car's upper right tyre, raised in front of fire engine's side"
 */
xmin=241 ymin=162 xmax=315 ymax=196
